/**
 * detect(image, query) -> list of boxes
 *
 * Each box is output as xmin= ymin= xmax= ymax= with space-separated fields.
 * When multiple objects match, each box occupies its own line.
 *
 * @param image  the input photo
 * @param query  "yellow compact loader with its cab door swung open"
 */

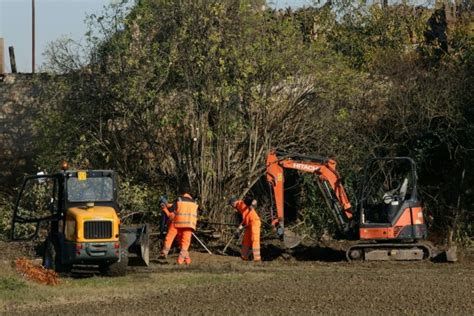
xmin=11 ymin=170 xmax=149 ymax=276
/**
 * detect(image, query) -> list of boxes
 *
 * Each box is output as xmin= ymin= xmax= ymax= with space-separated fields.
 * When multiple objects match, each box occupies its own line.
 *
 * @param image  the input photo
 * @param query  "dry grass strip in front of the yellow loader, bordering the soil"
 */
xmin=0 ymin=258 xmax=263 ymax=313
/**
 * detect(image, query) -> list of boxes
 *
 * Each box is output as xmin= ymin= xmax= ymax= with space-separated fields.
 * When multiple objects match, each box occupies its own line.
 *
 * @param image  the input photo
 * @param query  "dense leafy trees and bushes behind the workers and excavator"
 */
xmin=13 ymin=0 xmax=474 ymax=242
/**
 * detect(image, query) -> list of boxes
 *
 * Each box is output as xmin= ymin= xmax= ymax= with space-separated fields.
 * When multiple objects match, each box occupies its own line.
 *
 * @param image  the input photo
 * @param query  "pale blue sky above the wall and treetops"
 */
xmin=0 ymin=0 xmax=312 ymax=72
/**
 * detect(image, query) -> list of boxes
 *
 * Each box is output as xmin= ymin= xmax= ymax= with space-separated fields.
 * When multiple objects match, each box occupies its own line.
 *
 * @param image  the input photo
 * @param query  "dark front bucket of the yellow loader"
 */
xmin=120 ymin=224 xmax=150 ymax=266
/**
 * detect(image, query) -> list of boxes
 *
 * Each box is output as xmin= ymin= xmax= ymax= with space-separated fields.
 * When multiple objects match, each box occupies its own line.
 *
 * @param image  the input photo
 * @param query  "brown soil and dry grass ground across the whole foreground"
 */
xmin=0 ymin=241 xmax=474 ymax=315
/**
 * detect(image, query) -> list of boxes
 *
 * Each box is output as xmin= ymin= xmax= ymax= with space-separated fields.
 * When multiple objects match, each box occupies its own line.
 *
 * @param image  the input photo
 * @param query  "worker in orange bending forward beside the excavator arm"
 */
xmin=229 ymin=197 xmax=262 ymax=261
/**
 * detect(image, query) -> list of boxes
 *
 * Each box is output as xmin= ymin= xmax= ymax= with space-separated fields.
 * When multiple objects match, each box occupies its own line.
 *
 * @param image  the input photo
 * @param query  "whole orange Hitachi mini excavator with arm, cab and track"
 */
xmin=266 ymin=150 xmax=432 ymax=261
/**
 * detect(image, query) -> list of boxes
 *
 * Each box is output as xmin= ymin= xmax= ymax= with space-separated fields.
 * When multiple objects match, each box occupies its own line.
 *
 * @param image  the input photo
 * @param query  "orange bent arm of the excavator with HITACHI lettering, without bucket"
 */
xmin=266 ymin=150 xmax=352 ymax=236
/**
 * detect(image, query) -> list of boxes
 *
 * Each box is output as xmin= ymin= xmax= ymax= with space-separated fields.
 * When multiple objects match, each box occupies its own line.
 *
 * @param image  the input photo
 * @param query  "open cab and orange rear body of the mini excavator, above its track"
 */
xmin=358 ymin=157 xmax=427 ymax=240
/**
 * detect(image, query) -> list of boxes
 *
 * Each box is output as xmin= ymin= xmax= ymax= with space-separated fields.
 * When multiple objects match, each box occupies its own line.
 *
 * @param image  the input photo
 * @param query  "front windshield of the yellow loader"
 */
xmin=67 ymin=177 xmax=114 ymax=202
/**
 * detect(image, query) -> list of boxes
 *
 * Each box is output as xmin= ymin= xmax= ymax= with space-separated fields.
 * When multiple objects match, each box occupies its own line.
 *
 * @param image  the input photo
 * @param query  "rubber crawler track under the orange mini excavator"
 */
xmin=346 ymin=242 xmax=433 ymax=261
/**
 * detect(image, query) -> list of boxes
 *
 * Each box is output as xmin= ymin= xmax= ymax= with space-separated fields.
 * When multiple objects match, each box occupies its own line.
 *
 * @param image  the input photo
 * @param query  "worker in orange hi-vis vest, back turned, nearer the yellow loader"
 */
xmin=160 ymin=186 xmax=198 ymax=265
